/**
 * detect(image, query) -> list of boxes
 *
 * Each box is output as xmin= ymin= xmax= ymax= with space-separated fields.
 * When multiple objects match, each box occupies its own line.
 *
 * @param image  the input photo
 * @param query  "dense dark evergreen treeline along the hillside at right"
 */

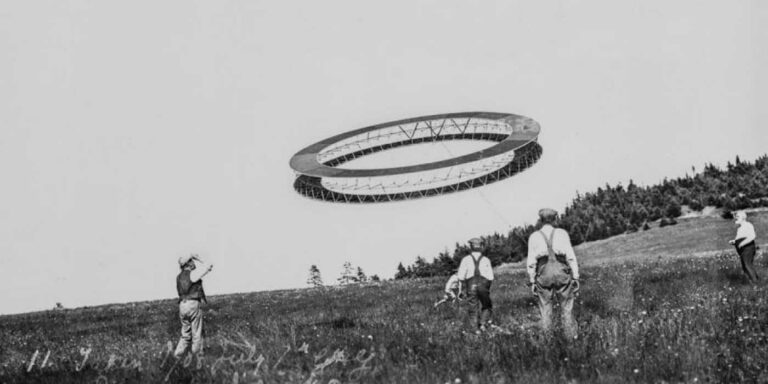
xmin=395 ymin=155 xmax=768 ymax=279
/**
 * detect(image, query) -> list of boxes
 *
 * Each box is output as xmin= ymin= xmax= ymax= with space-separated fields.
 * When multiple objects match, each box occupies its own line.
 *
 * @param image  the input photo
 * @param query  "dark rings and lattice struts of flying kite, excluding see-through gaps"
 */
xmin=290 ymin=112 xmax=542 ymax=203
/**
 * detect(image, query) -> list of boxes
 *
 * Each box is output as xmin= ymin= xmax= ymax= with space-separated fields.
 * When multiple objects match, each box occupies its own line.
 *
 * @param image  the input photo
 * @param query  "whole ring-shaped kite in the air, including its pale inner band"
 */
xmin=290 ymin=112 xmax=542 ymax=203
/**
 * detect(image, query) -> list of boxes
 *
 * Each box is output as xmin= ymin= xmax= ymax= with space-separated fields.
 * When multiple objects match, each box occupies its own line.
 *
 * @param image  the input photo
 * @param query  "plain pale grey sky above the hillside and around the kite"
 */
xmin=0 ymin=0 xmax=768 ymax=314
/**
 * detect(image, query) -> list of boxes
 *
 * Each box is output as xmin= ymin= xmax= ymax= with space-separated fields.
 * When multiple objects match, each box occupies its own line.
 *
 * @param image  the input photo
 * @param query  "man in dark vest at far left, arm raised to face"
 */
xmin=174 ymin=254 xmax=213 ymax=358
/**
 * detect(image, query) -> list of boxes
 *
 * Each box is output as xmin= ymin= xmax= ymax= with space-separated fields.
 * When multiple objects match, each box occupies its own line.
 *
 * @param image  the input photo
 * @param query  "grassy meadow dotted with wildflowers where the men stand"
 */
xmin=0 ymin=212 xmax=768 ymax=384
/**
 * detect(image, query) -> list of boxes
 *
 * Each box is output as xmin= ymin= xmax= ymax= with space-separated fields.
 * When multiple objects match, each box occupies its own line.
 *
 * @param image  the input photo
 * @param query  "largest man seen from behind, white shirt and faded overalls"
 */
xmin=527 ymin=208 xmax=579 ymax=338
